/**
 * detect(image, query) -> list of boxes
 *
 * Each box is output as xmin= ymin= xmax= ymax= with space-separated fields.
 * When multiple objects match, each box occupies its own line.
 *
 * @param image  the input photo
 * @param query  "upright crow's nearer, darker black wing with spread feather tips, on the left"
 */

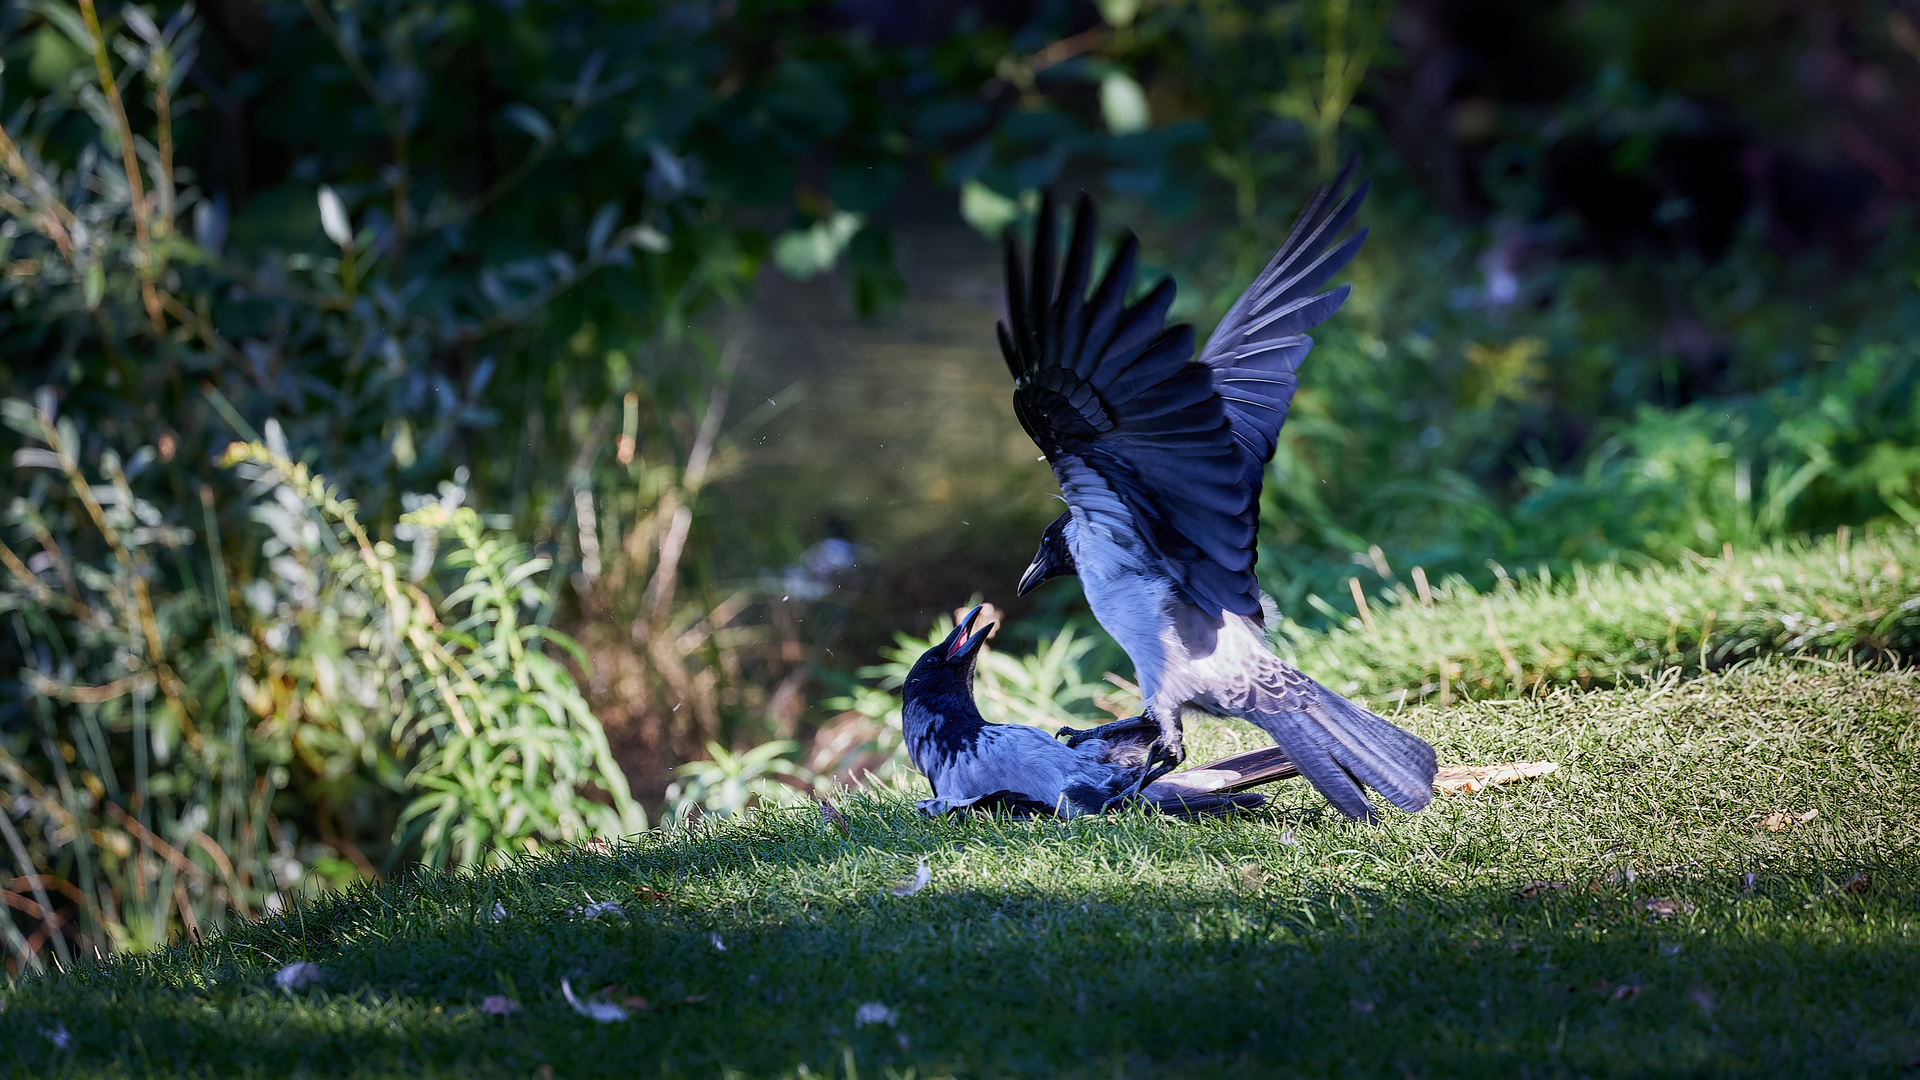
xmin=1000 ymin=196 xmax=1260 ymax=617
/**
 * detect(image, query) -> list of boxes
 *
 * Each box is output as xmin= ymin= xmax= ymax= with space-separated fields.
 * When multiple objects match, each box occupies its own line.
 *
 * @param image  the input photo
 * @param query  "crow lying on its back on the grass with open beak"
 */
xmin=900 ymin=607 xmax=1300 ymax=817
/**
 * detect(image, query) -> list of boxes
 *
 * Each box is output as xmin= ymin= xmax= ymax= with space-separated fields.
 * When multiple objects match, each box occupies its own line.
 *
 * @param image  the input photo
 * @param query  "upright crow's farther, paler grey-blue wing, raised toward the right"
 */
xmin=1200 ymin=161 xmax=1369 ymax=488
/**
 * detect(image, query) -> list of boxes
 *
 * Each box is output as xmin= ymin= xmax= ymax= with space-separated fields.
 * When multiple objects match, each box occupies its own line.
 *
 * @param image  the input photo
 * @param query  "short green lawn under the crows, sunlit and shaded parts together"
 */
xmin=0 ymin=661 xmax=1920 ymax=1078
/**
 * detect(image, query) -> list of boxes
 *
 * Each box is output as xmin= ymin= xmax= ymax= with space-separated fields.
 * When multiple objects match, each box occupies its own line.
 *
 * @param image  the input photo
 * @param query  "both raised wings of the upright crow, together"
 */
xmin=998 ymin=176 xmax=1367 ymax=619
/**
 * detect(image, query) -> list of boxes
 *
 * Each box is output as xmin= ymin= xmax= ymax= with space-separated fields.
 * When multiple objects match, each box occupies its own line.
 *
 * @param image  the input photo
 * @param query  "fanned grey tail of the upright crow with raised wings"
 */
xmin=1246 ymin=684 xmax=1438 ymax=821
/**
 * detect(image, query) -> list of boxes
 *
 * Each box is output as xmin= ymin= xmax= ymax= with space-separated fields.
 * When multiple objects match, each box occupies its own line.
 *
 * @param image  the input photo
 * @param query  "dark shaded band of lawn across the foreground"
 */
xmin=0 ymin=813 xmax=1920 ymax=1076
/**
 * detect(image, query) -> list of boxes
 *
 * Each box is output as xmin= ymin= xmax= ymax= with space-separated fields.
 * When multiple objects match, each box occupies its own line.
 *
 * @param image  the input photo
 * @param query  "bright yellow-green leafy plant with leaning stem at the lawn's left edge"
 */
xmin=223 ymin=432 xmax=647 ymax=865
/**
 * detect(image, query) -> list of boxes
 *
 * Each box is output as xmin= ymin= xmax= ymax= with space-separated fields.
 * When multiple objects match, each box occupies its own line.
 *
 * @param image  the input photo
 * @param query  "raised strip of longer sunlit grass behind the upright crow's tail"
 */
xmin=1281 ymin=527 xmax=1920 ymax=707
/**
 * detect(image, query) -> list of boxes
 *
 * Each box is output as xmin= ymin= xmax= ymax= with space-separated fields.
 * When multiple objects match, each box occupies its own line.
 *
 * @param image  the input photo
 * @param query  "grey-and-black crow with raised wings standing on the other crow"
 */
xmin=998 ymin=173 xmax=1434 ymax=821
